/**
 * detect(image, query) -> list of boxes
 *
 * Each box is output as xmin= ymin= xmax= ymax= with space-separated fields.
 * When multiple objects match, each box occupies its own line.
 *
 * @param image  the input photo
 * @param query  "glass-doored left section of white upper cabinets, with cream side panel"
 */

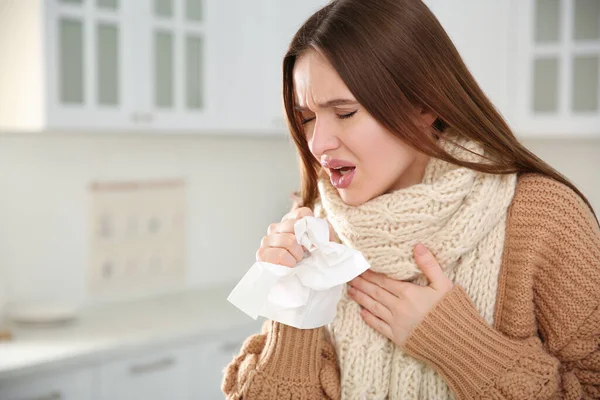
xmin=0 ymin=0 xmax=218 ymax=132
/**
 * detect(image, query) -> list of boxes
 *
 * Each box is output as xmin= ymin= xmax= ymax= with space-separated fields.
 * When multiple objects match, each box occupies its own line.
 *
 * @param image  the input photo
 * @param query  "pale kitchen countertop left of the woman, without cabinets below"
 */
xmin=0 ymin=285 xmax=260 ymax=381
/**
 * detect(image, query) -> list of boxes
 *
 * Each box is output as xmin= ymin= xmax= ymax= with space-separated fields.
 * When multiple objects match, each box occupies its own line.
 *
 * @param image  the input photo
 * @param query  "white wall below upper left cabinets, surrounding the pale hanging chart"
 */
xmin=0 ymin=134 xmax=299 ymax=308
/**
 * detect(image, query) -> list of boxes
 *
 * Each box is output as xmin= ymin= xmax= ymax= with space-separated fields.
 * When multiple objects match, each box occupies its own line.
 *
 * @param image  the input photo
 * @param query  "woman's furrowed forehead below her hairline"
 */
xmin=294 ymin=50 xmax=353 ymax=106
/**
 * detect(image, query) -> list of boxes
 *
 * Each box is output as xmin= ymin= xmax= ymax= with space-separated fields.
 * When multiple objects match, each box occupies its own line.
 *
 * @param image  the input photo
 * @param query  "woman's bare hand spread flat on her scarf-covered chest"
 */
xmin=348 ymin=244 xmax=454 ymax=346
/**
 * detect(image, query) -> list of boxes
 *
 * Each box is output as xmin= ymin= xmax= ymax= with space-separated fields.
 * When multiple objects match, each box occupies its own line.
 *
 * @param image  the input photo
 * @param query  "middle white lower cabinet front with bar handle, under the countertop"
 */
xmin=99 ymin=349 xmax=189 ymax=400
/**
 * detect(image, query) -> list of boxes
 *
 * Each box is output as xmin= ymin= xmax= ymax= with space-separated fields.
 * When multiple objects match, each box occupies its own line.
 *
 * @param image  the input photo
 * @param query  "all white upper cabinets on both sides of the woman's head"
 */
xmin=0 ymin=0 xmax=600 ymax=137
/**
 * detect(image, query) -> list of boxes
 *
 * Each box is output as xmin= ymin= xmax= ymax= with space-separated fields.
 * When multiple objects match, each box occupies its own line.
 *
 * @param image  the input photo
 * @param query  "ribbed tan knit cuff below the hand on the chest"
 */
xmin=405 ymin=286 xmax=522 ymax=398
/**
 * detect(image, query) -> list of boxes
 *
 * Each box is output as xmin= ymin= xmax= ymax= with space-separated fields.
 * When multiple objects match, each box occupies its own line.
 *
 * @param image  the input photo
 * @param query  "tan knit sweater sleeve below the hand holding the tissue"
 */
xmin=222 ymin=321 xmax=340 ymax=400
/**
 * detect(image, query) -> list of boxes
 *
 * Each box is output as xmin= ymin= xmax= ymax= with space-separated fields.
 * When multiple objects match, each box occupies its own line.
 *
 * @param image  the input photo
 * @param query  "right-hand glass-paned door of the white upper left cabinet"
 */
xmin=132 ymin=0 xmax=216 ymax=131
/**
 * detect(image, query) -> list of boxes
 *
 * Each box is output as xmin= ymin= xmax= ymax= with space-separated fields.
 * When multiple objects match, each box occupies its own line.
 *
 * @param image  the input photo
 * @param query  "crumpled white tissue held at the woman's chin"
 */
xmin=227 ymin=217 xmax=369 ymax=329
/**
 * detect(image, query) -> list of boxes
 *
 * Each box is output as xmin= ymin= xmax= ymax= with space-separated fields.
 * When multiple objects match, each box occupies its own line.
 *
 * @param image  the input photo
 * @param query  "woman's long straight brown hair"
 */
xmin=283 ymin=0 xmax=593 ymax=225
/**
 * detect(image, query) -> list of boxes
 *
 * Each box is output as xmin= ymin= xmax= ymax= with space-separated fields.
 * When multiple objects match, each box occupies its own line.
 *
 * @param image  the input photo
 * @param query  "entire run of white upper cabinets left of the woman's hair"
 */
xmin=0 ymin=0 xmax=326 ymax=134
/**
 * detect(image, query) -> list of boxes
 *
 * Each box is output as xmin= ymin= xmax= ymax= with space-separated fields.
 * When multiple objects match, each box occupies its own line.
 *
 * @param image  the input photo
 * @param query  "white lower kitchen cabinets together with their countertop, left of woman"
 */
xmin=0 ymin=283 xmax=262 ymax=400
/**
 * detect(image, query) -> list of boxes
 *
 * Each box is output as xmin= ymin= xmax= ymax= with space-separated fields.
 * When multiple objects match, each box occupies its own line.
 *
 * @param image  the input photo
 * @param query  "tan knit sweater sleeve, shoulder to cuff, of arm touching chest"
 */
xmin=406 ymin=177 xmax=600 ymax=399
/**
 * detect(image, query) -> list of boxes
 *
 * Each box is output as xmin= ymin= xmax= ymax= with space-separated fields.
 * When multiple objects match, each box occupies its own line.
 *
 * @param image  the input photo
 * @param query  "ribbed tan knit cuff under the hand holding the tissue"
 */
xmin=259 ymin=321 xmax=324 ymax=383
